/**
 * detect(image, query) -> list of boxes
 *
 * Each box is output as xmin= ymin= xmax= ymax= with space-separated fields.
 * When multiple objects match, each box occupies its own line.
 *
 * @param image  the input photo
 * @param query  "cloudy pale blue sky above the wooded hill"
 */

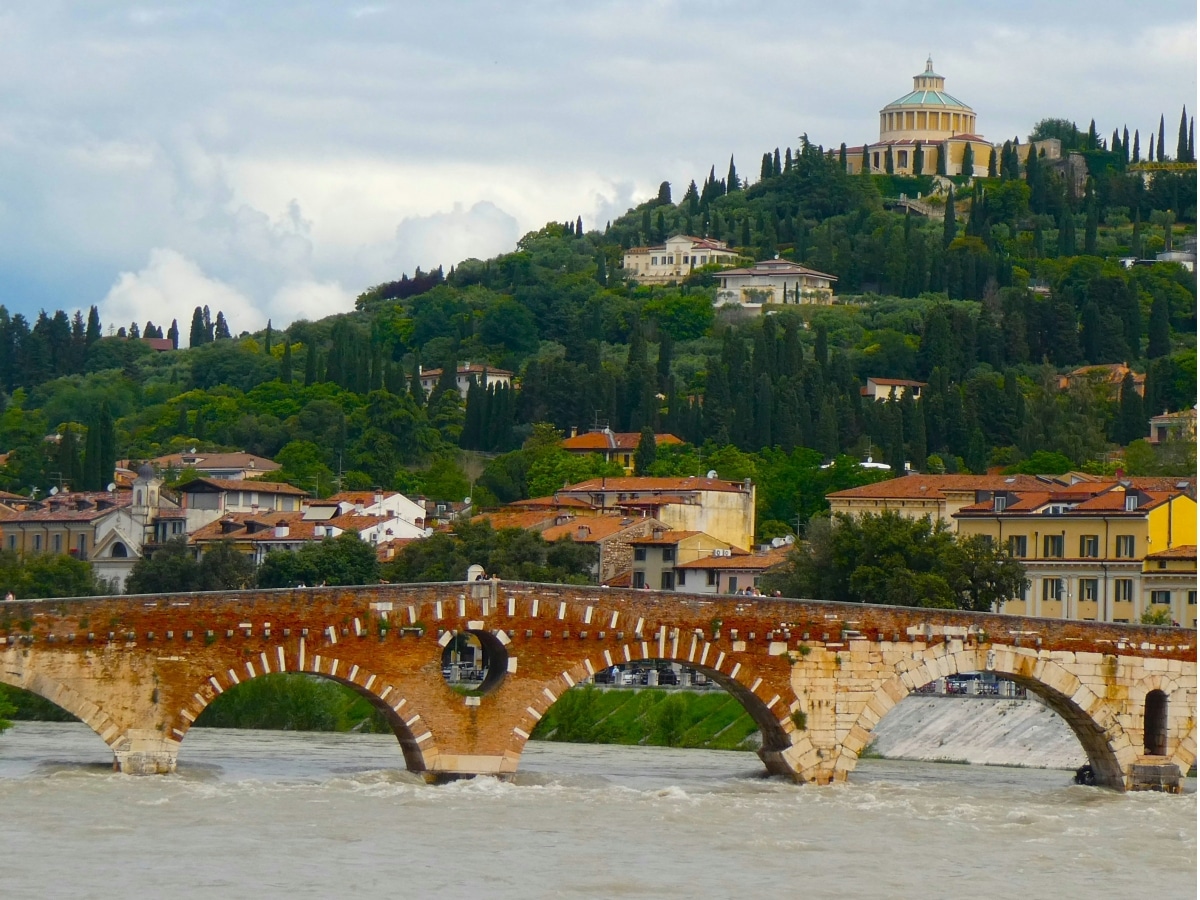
xmin=0 ymin=0 xmax=1196 ymax=332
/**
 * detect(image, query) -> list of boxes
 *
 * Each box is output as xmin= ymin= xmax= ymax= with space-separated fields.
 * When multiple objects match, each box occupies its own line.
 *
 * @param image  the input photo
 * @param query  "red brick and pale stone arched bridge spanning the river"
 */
xmin=0 ymin=581 xmax=1196 ymax=790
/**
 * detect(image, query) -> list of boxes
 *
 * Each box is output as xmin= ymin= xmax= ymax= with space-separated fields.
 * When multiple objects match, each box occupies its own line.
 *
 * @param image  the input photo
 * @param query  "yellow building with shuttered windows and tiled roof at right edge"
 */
xmin=954 ymin=482 xmax=1196 ymax=628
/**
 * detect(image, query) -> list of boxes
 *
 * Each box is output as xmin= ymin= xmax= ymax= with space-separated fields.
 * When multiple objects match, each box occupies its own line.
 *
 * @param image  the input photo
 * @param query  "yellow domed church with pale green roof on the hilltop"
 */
xmin=846 ymin=58 xmax=1057 ymax=175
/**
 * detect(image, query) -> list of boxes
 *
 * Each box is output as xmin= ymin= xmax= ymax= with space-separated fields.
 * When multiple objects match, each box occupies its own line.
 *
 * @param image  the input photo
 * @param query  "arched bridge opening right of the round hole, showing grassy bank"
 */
xmin=532 ymin=659 xmax=787 ymax=764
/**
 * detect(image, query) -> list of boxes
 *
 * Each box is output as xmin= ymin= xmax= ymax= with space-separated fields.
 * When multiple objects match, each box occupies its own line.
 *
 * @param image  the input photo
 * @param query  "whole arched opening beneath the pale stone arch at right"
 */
xmin=859 ymin=671 xmax=1121 ymax=784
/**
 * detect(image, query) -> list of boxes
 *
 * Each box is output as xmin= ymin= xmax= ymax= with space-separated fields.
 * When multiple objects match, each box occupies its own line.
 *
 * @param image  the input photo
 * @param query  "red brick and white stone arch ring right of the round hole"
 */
xmin=492 ymin=638 xmax=803 ymax=778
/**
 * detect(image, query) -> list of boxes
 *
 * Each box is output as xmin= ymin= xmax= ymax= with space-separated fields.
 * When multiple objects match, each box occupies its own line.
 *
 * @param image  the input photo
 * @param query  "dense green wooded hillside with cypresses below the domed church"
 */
xmin=0 ymin=120 xmax=1196 ymax=536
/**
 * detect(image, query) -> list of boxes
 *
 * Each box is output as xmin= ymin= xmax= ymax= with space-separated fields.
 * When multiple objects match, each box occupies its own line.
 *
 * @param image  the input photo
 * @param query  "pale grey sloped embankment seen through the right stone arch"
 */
xmin=866 ymin=695 xmax=1087 ymax=769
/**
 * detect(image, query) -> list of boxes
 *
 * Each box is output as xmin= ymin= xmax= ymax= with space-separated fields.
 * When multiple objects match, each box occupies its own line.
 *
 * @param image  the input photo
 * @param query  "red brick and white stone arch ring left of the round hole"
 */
xmin=170 ymin=644 xmax=439 ymax=773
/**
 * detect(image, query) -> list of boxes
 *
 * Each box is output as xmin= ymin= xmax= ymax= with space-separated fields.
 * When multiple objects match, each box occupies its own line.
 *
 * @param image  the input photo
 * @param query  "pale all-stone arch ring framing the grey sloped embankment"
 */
xmin=835 ymin=644 xmax=1135 ymax=790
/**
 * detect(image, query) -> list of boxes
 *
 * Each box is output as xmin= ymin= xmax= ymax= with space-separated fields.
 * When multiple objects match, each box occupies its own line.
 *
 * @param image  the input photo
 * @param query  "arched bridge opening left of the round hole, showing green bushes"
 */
xmin=180 ymin=672 xmax=424 ymax=772
